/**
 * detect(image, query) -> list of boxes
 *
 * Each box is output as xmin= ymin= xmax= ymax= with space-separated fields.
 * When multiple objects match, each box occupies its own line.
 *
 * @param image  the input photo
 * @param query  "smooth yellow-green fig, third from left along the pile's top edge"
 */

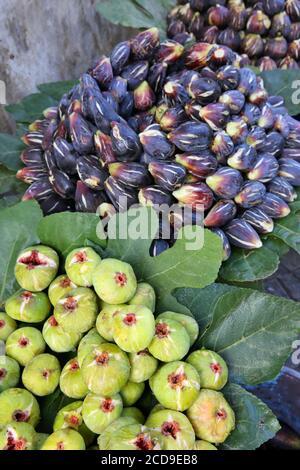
xmin=93 ymin=258 xmax=137 ymax=305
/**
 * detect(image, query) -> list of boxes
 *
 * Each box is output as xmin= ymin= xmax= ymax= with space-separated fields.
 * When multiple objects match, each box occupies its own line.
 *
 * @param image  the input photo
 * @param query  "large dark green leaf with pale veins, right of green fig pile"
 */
xmin=199 ymin=288 xmax=300 ymax=385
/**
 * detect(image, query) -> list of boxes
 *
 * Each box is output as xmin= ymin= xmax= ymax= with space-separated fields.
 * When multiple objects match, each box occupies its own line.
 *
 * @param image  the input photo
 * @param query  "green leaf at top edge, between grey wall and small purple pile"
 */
xmin=97 ymin=0 xmax=176 ymax=31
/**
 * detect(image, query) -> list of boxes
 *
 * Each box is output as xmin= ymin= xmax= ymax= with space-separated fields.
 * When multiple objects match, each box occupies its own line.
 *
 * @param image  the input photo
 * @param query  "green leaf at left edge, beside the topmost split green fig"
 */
xmin=0 ymin=201 xmax=43 ymax=306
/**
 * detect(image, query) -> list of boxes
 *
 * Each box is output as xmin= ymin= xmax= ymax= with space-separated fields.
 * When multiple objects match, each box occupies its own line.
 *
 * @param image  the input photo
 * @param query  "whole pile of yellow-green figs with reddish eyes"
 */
xmin=0 ymin=246 xmax=235 ymax=451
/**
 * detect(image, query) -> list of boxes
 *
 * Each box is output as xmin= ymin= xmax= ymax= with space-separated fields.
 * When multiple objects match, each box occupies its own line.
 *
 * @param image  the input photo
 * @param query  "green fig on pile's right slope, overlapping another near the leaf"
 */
xmin=148 ymin=318 xmax=190 ymax=362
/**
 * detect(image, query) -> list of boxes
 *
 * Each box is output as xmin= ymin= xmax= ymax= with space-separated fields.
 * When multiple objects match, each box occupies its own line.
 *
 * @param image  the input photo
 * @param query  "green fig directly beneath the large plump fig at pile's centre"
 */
xmin=82 ymin=393 xmax=123 ymax=434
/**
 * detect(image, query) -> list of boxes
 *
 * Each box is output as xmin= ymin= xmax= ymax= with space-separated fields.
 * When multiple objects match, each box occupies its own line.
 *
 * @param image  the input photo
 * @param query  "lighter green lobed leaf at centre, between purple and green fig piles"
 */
xmin=108 ymin=208 xmax=222 ymax=311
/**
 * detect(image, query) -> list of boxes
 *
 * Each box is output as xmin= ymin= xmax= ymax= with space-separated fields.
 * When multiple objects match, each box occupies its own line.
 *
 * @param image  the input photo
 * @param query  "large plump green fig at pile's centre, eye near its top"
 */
xmin=81 ymin=343 xmax=130 ymax=396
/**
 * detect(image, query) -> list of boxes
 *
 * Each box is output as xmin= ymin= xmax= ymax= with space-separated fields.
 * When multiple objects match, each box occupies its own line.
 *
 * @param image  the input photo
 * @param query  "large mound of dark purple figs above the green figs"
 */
xmin=17 ymin=28 xmax=300 ymax=259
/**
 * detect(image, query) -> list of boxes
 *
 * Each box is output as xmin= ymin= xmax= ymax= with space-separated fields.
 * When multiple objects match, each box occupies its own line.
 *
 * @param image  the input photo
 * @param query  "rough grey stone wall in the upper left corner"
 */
xmin=0 ymin=0 xmax=132 ymax=132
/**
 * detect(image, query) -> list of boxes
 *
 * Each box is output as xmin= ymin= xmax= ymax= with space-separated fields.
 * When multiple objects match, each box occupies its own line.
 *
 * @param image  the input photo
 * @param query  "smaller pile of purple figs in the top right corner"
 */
xmin=168 ymin=0 xmax=300 ymax=70
